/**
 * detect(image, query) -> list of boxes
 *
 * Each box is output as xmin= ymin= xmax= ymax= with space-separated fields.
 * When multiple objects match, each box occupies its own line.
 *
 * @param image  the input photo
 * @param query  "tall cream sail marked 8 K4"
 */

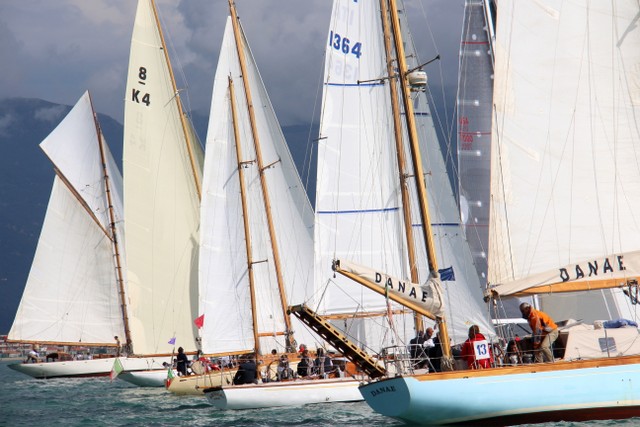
xmin=124 ymin=0 xmax=200 ymax=355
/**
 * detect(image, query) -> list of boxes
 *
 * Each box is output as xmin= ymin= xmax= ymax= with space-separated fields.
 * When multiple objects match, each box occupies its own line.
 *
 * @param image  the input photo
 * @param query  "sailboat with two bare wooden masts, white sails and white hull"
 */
xmin=195 ymin=1 xmax=362 ymax=409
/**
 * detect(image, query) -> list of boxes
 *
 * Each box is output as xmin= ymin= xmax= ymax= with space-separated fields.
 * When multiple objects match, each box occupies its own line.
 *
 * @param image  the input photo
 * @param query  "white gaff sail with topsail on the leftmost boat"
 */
xmin=9 ymin=92 xmax=124 ymax=344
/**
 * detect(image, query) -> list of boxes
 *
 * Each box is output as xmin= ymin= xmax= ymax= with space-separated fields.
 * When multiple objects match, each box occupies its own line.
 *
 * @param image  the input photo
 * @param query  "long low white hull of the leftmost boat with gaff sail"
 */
xmin=9 ymin=357 xmax=115 ymax=379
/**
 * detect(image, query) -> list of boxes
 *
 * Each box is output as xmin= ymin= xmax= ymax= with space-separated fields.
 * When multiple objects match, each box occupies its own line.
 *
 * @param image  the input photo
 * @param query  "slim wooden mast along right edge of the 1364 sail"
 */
xmin=380 ymin=0 xmax=423 ymax=331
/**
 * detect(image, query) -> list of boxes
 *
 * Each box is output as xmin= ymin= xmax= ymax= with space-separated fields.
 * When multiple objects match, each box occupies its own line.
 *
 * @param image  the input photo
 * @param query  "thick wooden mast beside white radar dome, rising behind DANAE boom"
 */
xmin=383 ymin=0 xmax=451 ymax=360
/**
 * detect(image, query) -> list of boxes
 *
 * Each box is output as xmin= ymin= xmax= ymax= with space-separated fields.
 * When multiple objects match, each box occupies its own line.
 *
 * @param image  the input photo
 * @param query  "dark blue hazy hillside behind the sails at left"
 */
xmin=0 ymin=98 xmax=318 ymax=334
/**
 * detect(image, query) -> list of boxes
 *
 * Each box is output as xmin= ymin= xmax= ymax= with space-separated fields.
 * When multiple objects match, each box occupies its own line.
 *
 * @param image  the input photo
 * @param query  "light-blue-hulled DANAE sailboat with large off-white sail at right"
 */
xmin=360 ymin=1 xmax=640 ymax=425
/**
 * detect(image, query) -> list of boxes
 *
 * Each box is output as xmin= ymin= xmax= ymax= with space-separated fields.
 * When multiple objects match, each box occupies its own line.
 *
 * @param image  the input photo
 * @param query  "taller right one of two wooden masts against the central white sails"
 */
xmin=229 ymin=0 xmax=294 ymax=351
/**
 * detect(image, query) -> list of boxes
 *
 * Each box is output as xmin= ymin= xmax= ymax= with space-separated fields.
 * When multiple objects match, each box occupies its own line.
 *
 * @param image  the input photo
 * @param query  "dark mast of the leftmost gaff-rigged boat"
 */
xmin=89 ymin=97 xmax=132 ymax=351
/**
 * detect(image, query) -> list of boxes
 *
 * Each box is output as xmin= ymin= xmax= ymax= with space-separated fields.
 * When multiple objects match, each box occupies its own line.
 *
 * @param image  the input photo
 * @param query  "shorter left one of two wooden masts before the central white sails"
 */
xmin=229 ymin=76 xmax=260 ymax=357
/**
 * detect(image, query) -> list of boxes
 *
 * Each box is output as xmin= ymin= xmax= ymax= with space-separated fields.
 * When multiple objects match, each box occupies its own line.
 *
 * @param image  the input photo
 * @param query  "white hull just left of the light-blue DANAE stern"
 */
xmin=204 ymin=378 xmax=363 ymax=409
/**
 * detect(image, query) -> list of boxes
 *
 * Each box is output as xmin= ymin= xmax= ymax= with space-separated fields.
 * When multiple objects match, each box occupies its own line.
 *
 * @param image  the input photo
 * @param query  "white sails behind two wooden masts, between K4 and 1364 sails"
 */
xmin=200 ymin=18 xmax=317 ymax=353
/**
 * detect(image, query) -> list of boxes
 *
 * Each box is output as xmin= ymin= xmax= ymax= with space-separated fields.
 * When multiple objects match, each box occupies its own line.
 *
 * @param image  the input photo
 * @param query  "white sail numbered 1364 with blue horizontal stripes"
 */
xmin=315 ymin=1 xmax=414 ymax=349
